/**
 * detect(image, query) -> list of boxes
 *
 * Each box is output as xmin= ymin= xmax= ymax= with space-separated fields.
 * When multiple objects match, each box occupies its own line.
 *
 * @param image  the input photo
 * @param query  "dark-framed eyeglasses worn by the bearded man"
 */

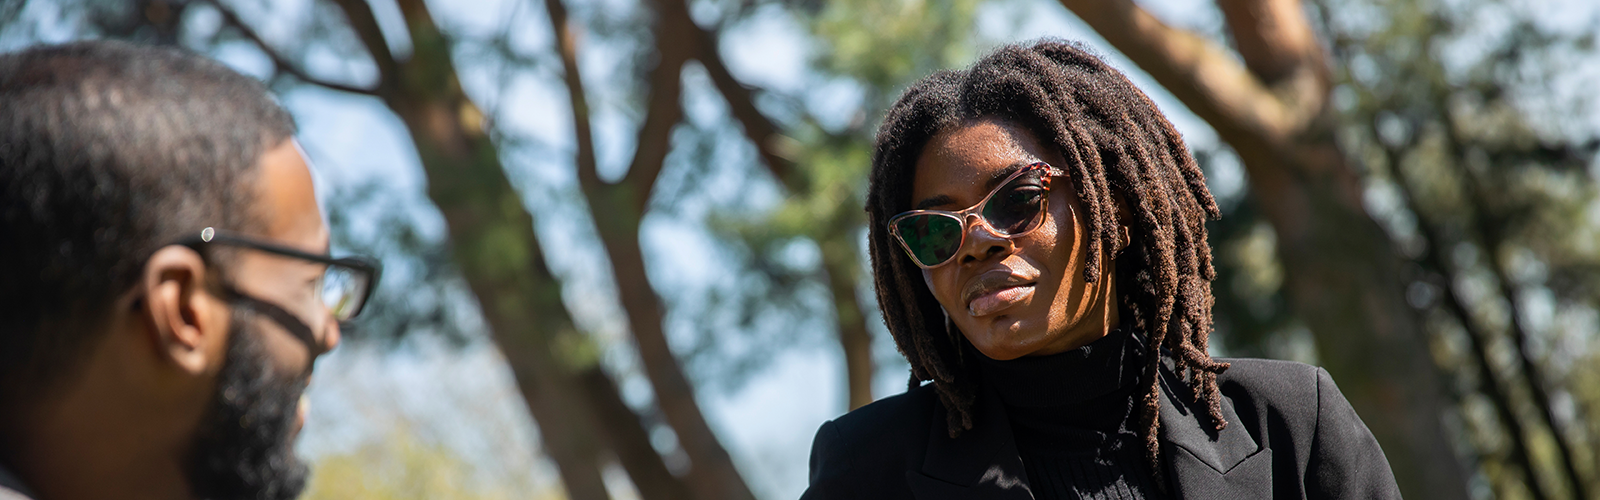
xmin=179 ymin=228 xmax=382 ymax=353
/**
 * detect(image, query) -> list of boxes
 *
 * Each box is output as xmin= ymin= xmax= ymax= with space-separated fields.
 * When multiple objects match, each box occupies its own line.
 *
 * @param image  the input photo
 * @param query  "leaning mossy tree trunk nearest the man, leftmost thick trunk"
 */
xmin=320 ymin=0 xmax=700 ymax=500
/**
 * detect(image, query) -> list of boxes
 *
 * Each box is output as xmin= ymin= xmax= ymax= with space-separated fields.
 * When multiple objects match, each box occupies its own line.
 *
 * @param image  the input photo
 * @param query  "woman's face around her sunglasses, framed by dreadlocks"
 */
xmin=912 ymin=119 xmax=1117 ymax=361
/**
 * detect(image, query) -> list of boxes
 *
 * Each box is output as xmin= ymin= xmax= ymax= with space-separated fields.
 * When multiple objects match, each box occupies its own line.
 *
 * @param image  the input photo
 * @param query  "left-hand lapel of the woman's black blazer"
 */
xmin=906 ymin=384 xmax=1034 ymax=500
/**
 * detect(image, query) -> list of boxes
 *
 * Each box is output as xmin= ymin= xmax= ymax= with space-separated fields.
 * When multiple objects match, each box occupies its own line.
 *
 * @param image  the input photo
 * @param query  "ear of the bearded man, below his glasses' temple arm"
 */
xmin=134 ymin=245 xmax=229 ymax=373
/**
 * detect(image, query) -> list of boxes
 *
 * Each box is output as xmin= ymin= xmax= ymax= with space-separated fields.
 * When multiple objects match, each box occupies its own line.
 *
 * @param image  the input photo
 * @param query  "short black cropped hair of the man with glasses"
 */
xmin=0 ymin=42 xmax=294 ymax=402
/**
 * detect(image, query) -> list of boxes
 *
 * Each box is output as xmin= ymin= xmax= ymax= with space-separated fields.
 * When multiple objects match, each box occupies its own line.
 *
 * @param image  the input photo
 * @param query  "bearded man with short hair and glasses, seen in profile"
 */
xmin=0 ymin=42 xmax=378 ymax=500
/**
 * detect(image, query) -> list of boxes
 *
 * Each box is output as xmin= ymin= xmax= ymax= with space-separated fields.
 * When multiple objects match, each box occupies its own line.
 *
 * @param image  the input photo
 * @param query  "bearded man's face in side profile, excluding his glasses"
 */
xmin=189 ymin=141 xmax=339 ymax=498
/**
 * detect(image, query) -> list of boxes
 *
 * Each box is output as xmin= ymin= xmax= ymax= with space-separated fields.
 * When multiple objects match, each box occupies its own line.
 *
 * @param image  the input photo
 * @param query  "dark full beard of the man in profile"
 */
xmin=187 ymin=308 xmax=310 ymax=500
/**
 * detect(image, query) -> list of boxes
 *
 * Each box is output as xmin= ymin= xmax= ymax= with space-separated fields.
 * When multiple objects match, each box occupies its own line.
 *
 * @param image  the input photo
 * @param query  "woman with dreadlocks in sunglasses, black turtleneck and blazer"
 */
xmin=803 ymin=40 xmax=1400 ymax=498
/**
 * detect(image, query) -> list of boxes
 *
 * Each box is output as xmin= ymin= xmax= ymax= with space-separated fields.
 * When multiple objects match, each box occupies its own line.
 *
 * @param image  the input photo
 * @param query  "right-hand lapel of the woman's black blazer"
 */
xmin=1160 ymin=365 xmax=1272 ymax=498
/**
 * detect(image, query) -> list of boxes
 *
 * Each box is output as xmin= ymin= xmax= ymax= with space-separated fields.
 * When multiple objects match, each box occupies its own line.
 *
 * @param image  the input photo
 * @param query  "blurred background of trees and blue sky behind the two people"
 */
xmin=0 ymin=0 xmax=1600 ymax=498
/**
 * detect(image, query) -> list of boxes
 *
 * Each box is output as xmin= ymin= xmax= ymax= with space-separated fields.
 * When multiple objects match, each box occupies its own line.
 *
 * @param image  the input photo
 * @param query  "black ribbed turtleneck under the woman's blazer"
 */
xmin=973 ymin=330 xmax=1163 ymax=500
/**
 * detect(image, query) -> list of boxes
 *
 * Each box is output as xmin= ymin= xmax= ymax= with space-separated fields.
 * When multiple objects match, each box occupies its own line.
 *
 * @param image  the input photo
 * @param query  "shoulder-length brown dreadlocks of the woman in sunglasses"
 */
xmin=867 ymin=40 xmax=1227 ymax=476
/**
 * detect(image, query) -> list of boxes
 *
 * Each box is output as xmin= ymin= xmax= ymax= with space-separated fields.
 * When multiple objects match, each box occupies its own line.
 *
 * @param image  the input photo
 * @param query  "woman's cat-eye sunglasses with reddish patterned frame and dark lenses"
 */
xmin=890 ymin=162 xmax=1066 ymax=269
